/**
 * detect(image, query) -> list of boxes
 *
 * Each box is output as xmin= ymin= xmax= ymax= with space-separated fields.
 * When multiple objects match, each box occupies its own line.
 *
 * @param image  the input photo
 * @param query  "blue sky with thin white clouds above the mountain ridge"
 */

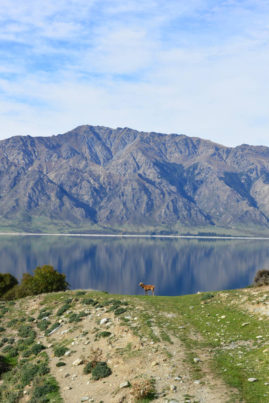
xmin=0 ymin=0 xmax=269 ymax=146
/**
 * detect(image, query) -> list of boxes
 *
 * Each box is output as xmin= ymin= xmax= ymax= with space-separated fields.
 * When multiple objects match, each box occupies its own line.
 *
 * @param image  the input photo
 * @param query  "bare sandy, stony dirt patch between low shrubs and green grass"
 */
xmin=35 ymin=296 xmax=237 ymax=403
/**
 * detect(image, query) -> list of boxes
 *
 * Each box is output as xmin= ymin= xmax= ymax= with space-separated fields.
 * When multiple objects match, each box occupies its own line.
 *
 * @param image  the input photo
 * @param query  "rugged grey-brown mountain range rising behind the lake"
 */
xmin=0 ymin=126 xmax=269 ymax=234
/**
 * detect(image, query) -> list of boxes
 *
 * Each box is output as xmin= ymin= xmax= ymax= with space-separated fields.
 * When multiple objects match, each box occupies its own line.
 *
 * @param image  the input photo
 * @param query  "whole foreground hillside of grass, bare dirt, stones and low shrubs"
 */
xmin=0 ymin=286 xmax=269 ymax=403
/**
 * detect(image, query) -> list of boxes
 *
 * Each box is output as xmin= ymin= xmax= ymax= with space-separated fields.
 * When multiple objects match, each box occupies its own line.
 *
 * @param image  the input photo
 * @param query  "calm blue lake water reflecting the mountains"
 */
xmin=0 ymin=236 xmax=269 ymax=295
